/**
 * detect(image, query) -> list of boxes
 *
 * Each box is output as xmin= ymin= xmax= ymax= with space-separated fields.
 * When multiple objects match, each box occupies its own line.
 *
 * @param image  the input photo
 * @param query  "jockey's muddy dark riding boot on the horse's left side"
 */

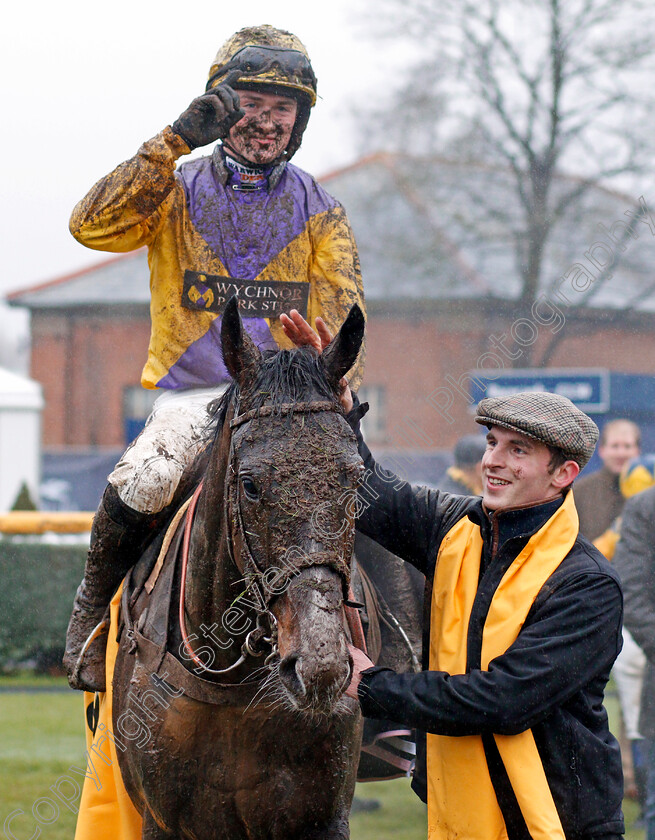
xmin=64 ymin=484 xmax=156 ymax=691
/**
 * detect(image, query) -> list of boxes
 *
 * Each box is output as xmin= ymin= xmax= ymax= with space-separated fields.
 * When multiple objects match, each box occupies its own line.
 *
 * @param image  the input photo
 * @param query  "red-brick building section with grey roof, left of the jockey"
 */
xmin=9 ymin=250 xmax=154 ymax=448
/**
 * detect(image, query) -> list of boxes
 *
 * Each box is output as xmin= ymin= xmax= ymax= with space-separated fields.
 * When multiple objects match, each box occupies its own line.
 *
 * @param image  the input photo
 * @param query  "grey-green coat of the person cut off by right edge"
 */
xmin=612 ymin=487 xmax=655 ymax=739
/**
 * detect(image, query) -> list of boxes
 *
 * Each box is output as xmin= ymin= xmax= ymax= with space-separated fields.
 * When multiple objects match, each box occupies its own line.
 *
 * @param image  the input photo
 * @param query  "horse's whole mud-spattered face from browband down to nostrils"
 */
xmin=231 ymin=412 xmax=362 ymax=714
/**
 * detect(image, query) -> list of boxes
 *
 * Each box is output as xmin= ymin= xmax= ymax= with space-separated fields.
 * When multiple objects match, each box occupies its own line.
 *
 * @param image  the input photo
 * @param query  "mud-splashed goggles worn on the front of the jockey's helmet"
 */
xmin=205 ymin=46 xmax=316 ymax=104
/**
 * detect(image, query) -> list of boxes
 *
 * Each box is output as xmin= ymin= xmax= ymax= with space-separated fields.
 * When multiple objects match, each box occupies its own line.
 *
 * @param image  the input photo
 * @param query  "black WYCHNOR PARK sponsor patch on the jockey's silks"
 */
xmin=182 ymin=269 xmax=309 ymax=318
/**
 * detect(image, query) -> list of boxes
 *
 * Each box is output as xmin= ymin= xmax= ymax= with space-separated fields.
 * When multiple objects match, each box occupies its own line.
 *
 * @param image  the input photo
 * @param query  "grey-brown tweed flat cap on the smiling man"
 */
xmin=475 ymin=391 xmax=598 ymax=469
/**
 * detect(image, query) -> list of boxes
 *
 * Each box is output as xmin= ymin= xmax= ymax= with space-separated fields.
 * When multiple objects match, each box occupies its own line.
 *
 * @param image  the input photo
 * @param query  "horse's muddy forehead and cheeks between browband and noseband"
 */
xmin=233 ymin=412 xmax=362 ymax=584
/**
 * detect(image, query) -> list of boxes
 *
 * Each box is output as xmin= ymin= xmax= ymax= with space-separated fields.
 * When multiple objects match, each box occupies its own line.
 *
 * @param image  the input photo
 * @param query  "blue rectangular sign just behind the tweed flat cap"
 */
xmin=469 ymin=368 xmax=610 ymax=414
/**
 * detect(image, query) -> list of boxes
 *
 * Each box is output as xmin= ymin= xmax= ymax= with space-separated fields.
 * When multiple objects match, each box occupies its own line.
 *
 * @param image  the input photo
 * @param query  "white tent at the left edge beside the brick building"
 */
xmin=0 ymin=368 xmax=43 ymax=511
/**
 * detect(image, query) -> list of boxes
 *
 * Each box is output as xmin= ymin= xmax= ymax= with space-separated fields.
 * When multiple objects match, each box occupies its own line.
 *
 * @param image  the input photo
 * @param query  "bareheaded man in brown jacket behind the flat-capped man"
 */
xmin=573 ymin=419 xmax=641 ymax=542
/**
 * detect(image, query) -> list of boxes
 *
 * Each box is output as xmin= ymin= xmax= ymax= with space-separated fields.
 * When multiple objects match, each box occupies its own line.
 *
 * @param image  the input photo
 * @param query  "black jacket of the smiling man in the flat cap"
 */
xmin=357 ymin=426 xmax=624 ymax=840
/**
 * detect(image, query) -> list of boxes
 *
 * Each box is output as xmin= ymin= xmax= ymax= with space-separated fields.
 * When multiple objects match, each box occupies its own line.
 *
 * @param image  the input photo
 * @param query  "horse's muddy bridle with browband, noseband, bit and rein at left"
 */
xmin=179 ymin=401 xmax=350 ymax=675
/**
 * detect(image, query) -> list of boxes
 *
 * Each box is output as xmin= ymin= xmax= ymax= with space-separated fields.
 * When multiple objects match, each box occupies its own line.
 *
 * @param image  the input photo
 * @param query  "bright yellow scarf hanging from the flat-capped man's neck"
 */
xmin=427 ymin=492 xmax=579 ymax=840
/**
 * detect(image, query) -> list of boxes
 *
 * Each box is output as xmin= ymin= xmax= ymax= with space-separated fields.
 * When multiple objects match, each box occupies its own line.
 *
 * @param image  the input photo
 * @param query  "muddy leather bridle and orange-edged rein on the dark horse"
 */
xmin=179 ymin=401 xmax=354 ymax=674
